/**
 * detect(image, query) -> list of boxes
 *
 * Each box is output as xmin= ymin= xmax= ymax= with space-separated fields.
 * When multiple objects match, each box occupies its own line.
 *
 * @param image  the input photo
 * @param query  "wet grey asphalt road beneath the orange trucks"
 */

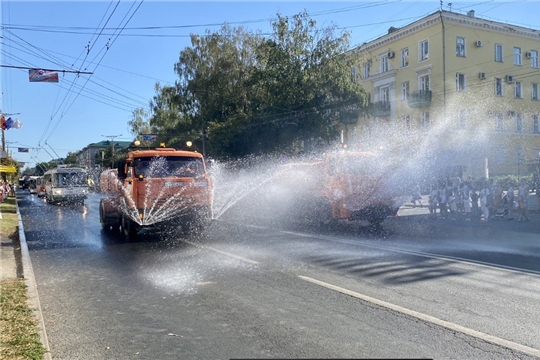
xmin=14 ymin=192 xmax=540 ymax=359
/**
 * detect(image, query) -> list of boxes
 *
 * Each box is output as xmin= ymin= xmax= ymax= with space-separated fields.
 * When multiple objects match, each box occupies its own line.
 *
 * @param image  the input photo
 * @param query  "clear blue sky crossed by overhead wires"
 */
xmin=0 ymin=0 xmax=540 ymax=168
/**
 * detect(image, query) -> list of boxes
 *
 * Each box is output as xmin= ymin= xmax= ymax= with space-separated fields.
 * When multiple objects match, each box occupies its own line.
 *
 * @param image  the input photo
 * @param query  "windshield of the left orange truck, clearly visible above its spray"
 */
xmin=133 ymin=156 xmax=204 ymax=178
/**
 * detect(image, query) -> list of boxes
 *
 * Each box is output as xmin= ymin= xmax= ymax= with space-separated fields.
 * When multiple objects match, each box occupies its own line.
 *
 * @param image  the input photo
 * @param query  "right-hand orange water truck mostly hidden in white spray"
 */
xmin=273 ymin=150 xmax=400 ymax=226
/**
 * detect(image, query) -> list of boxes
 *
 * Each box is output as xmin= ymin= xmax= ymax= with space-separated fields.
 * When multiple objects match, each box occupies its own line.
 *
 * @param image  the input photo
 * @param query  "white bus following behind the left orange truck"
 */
xmin=43 ymin=165 xmax=88 ymax=204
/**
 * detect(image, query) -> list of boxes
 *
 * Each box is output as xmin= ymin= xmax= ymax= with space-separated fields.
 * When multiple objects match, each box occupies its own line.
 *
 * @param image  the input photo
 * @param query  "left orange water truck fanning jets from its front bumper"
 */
xmin=99 ymin=143 xmax=212 ymax=240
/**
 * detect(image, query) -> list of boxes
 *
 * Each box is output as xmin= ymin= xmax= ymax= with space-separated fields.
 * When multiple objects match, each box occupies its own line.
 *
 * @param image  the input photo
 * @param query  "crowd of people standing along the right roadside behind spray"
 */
xmin=411 ymin=175 xmax=540 ymax=222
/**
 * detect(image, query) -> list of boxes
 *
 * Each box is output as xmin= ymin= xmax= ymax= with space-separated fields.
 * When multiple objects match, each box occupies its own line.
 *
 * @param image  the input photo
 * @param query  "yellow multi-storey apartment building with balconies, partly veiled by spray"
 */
xmin=344 ymin=10 xmax=540 ymax=178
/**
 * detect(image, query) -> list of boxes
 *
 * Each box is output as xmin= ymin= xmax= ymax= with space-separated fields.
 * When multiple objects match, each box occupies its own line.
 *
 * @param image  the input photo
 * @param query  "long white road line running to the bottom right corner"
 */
xmin=298 ymin=275 xmax=540 ymax=357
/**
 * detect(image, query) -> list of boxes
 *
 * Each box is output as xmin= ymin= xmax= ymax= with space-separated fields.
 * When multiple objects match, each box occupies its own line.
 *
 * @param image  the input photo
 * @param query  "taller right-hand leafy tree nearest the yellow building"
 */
xmin=246 ymin=12 xmax=366 ymax=150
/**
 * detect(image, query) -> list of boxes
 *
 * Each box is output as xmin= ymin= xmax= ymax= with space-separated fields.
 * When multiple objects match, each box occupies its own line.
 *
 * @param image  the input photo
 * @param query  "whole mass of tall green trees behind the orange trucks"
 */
xmin=141 ymin=13 xmax=366 ymax=157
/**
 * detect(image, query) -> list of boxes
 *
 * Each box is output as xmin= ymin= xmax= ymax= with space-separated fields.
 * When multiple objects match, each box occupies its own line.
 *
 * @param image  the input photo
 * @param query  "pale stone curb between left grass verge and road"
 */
xmin=17 ymin=206 xmax=52 ymax=360
